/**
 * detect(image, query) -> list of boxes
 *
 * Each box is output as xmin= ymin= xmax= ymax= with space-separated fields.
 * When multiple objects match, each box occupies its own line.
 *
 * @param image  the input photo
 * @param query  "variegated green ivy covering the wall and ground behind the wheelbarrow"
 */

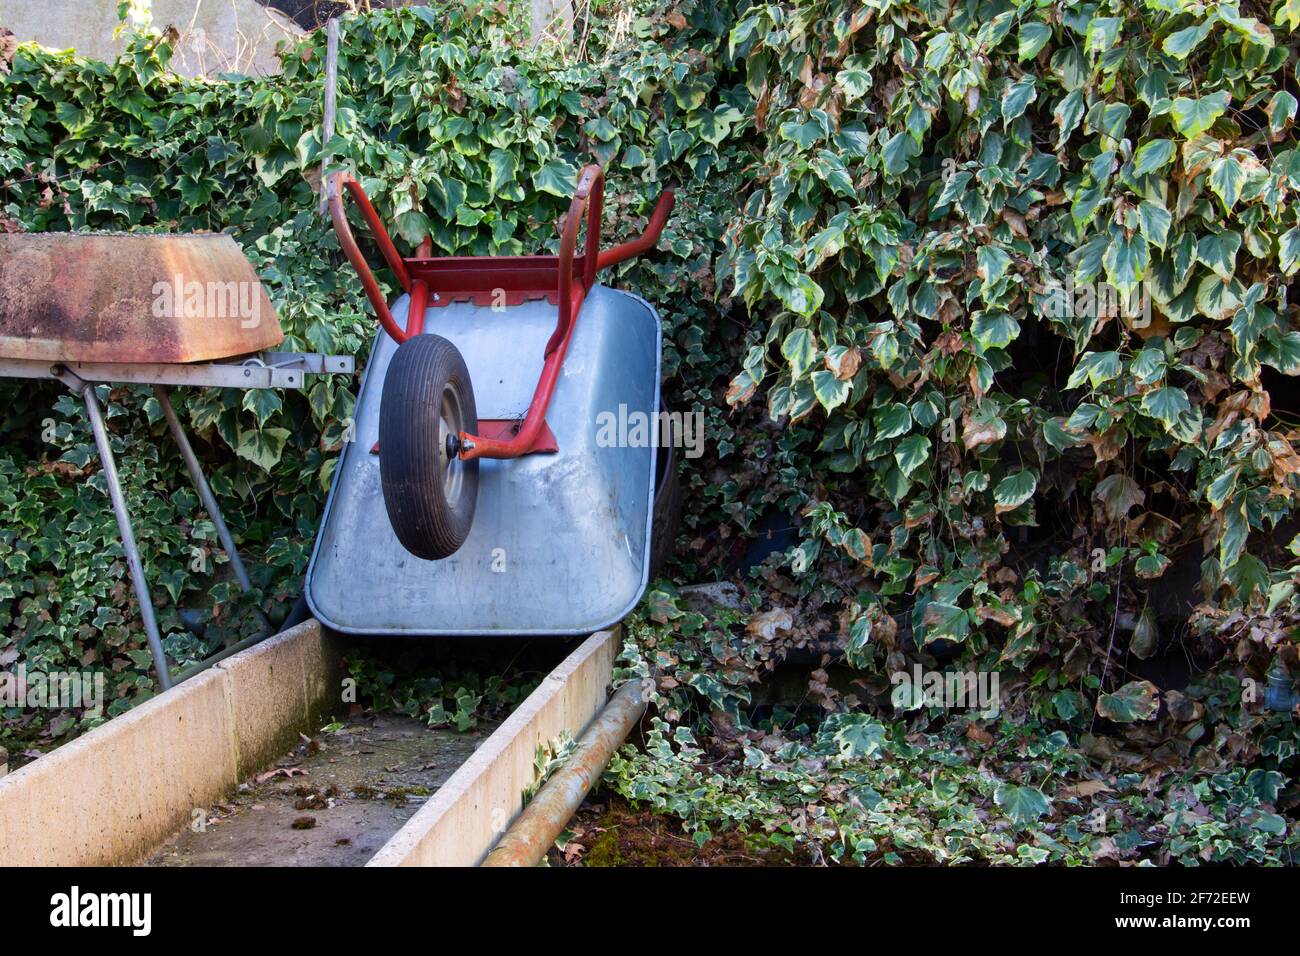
xmin=0 ymin=0 xmax=1300 ymax=861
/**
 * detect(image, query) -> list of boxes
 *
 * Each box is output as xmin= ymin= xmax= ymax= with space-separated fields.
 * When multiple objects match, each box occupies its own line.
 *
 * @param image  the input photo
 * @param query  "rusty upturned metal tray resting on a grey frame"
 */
xmin=0 ymin=233 xmax=283 ymax=363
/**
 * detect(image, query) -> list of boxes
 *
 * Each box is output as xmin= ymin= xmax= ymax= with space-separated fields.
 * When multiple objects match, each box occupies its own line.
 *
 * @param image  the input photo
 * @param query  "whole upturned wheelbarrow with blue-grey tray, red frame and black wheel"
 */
xmin=307 ymin=165 xmax=673 ymax=636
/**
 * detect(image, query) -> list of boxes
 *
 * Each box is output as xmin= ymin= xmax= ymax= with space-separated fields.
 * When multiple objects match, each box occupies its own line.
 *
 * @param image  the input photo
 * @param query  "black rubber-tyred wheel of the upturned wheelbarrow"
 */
xmin=380 ymin=336 xmax=478 ymax=561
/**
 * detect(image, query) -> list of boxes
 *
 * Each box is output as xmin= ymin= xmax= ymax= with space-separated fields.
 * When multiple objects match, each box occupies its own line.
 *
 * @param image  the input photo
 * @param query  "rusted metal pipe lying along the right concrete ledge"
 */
xmin=482 ymin=680 xmax=649 ymax=866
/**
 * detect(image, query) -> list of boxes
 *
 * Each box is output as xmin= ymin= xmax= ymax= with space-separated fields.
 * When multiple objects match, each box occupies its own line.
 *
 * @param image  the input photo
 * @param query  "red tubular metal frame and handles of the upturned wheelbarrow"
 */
xmin=329 ymin=165 xmax=673 ymax=460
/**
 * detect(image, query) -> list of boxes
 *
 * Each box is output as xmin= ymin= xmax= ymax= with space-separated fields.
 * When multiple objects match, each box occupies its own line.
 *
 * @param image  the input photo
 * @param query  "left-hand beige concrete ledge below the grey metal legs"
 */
xmin=0 ymin=620 xmax=338 ymax=866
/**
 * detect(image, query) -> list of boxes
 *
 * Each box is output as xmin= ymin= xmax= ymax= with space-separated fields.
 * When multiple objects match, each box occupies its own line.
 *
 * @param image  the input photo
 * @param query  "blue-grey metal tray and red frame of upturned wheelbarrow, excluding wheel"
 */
xmin=306 ymin=168 xmax=672 ymax=636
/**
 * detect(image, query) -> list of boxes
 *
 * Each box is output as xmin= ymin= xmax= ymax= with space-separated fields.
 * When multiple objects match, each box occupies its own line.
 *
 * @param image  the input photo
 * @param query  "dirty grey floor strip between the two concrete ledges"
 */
xmin=147 ymin=714 xmax=495 ymax=866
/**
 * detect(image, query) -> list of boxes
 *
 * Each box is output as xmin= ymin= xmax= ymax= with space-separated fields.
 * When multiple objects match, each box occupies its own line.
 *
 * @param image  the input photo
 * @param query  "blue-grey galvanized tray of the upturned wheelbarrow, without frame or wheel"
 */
xmin=307 ymin=286 xmax=660 ymax=636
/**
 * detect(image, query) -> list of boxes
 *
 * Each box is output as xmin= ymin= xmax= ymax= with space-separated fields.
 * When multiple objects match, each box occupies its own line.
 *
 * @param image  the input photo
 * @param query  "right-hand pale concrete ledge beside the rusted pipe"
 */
xmin=367 ymin=628 xmax=623 ymax=866
